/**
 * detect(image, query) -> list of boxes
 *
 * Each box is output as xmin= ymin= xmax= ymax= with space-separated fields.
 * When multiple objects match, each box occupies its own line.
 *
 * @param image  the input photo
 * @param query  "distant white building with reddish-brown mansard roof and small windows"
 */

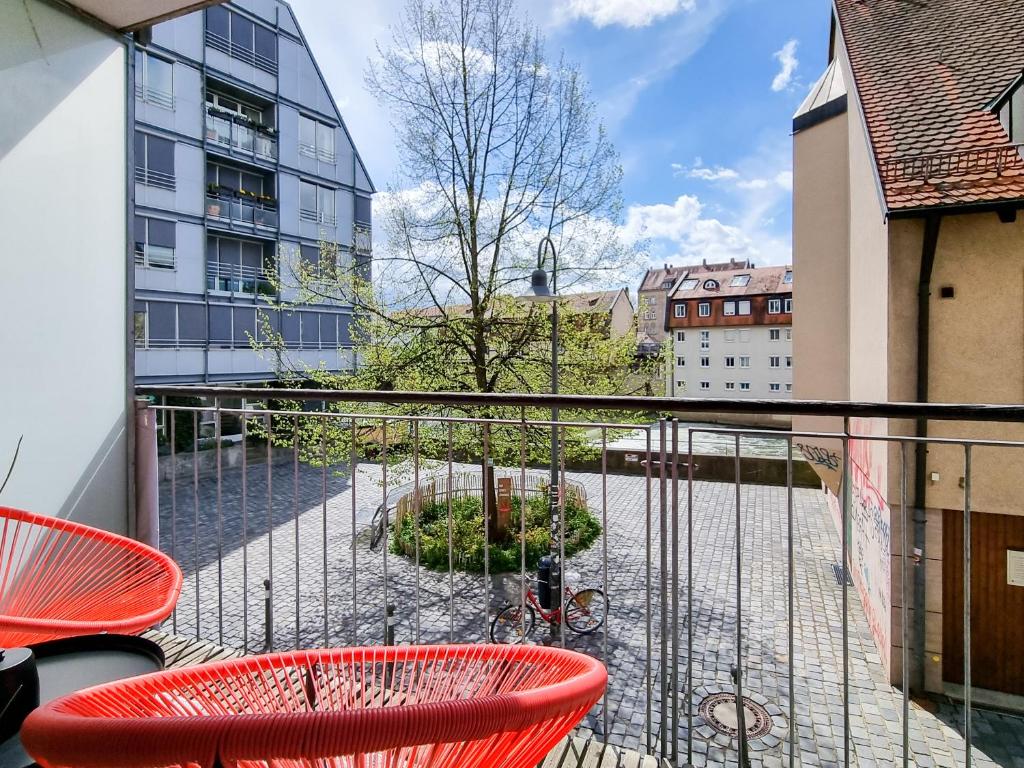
xmin=665 ymin=266 xmax=794 ymax=399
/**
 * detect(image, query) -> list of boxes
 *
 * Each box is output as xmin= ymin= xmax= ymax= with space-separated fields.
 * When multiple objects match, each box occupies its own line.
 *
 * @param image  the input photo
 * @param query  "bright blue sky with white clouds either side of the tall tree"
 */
xmin=292 ymin=0 xmax=830 ymax=264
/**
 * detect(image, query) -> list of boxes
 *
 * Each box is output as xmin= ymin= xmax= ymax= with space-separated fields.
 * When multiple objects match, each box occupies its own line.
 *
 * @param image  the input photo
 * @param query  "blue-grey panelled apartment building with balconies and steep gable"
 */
xmin=132 ymin=0 xmax=374 ymax=383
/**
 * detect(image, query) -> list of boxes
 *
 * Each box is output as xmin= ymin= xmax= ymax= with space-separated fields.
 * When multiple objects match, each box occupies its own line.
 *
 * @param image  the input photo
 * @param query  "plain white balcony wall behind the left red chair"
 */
xmin=0 ymin=0 xmax=129 ymax=532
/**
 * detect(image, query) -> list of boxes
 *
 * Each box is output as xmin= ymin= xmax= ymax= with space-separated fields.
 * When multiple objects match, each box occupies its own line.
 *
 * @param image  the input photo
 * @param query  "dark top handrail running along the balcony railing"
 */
xmin=136 ymin=386 xmax=1024 ymax=422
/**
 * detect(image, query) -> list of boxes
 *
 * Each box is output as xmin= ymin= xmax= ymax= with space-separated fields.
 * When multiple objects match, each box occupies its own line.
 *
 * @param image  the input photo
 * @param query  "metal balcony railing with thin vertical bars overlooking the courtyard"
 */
xmin=137 ymin=387 xmax=1024 ymax=768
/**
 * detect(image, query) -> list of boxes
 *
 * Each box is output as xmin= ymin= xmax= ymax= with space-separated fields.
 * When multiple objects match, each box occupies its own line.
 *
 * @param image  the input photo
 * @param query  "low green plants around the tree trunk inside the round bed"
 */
xmin=391 ymin=495 xmax=601 ymax=573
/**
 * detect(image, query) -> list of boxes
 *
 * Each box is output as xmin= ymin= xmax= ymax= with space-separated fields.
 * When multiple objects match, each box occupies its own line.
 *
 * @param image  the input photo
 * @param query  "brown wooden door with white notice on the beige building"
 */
xmin=942 ymin=510 xmax=1024 ymax=695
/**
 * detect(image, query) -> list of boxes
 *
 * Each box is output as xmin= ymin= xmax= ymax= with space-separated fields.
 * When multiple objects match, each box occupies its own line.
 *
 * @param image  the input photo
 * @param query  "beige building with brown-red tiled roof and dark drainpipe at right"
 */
xmin=793 ymin=0 xmax=1024 ymax=695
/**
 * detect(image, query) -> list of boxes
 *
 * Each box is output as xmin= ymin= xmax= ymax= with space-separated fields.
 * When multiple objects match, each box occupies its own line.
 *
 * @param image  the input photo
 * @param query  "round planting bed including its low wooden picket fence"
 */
xmin=391 ymin=474 xmax=601 ymax=573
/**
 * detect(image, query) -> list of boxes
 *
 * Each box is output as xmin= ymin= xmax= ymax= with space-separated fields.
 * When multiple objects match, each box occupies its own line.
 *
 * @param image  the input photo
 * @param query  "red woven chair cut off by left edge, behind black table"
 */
xmin=0 ymin=507 xmax=181 ymax=648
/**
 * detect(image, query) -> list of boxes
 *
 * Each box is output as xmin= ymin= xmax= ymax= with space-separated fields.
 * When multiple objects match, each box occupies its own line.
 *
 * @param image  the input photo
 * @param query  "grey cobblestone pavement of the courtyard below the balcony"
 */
xmin=155 ymin=462 xmax=1024 ymax=768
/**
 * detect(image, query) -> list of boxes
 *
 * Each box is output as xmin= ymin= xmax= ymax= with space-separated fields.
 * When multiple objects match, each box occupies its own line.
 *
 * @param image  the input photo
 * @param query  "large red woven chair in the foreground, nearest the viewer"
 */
xmin=22 ymin=645 xmax=607 ymax=768
